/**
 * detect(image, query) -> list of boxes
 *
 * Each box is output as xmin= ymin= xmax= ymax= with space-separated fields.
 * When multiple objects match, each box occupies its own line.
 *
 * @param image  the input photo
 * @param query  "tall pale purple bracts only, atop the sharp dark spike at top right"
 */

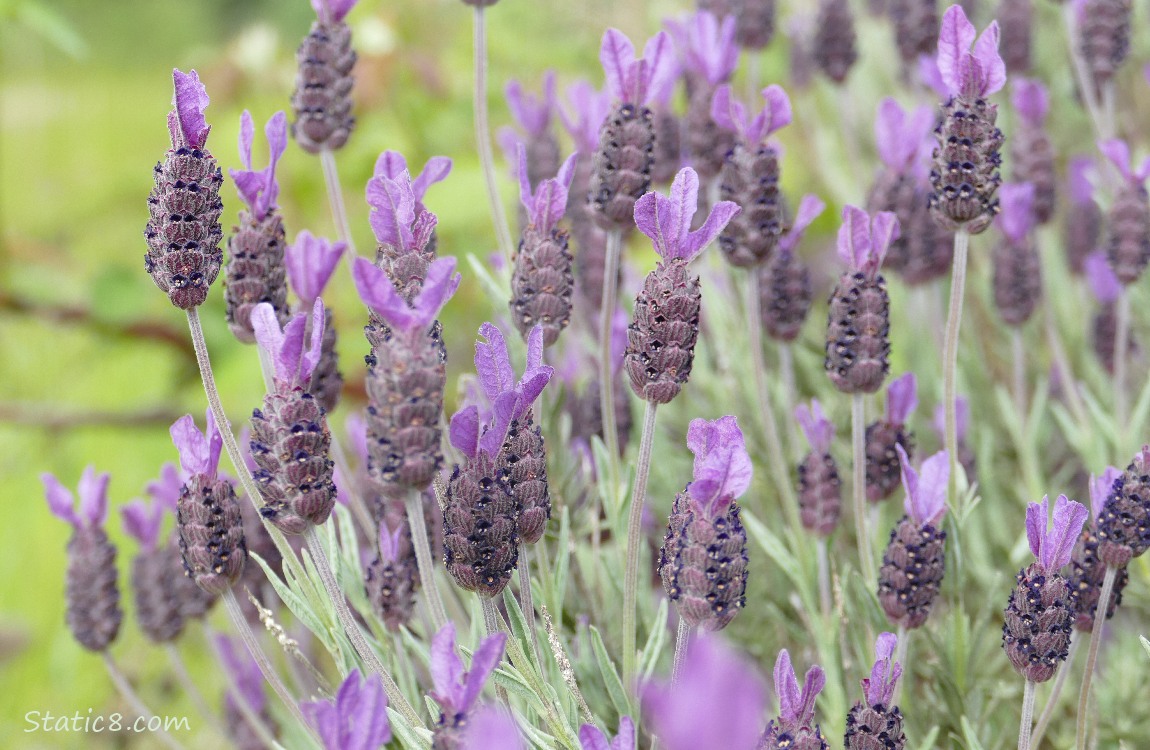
xmin=937 ymin=5 xmax=1006 ymax=98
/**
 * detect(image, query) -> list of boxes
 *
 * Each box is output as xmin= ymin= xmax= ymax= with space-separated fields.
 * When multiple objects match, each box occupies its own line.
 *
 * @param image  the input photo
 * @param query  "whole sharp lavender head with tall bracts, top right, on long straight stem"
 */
xmin=930 ymin=6 xmax=1006 ymax=235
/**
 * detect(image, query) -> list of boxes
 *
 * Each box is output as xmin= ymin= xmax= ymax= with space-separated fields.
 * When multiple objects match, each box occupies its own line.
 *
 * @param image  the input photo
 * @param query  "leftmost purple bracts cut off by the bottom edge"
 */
xmin=300 ymin=669 xmax=391 ymax=750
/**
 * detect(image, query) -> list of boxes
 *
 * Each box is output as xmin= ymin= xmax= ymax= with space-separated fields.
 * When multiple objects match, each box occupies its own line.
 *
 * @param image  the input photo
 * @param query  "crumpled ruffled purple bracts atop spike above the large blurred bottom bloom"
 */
xmin=687 ymin=416 xmax=754 ymax=515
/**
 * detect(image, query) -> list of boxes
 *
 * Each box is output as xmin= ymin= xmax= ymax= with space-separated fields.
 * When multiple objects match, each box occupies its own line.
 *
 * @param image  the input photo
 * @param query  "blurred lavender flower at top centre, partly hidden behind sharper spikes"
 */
xmin=668 ymin=10 xmax=738 ymax=182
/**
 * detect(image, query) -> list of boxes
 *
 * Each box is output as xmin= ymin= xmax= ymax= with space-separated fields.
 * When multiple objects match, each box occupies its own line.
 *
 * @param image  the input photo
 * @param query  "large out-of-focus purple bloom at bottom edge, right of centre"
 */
xmin=642 ymin=635 xmax=766 ymax=750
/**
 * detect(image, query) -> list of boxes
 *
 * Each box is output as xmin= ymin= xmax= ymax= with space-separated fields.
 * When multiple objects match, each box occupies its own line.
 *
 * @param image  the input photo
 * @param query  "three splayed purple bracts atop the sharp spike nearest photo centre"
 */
xmin=635 ymin=167 xmax=742 ymax=261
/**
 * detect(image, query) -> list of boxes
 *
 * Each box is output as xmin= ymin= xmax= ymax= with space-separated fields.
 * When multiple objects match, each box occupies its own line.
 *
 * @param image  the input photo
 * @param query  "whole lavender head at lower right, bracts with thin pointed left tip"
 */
xmin=879 ymin=445 xmax=950 ymax=628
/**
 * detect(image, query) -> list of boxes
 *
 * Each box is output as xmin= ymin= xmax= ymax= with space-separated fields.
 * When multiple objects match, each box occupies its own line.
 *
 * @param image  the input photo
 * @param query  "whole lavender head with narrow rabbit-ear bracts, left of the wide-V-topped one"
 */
xmin=250 ymin=299 xmax=336 ymax=534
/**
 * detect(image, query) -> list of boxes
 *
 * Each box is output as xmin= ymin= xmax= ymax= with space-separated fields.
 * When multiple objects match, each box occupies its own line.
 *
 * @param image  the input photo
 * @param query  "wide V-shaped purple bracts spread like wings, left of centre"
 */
xmin=352 ymin=255 xmax=460 ymax=331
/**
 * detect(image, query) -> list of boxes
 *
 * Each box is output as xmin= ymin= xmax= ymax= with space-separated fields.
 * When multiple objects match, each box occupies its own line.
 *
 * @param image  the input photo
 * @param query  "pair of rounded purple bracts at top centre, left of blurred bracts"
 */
xmin=599 ymin=29 xmax=679 ymax=106
